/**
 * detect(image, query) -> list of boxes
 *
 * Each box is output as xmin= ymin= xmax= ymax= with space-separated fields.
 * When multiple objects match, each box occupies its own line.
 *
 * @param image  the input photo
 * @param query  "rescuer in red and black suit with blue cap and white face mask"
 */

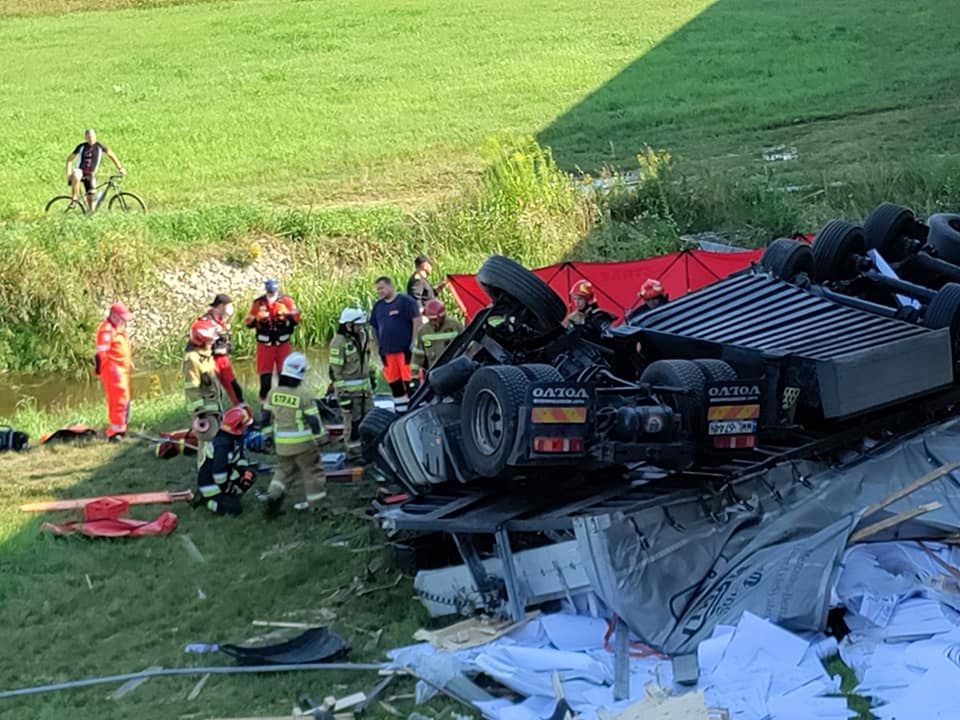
xmin=243 ymin=278 xmax=300 ymax=409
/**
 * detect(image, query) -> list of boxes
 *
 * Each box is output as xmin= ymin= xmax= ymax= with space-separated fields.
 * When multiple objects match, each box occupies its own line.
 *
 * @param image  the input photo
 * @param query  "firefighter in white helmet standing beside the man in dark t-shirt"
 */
xmin=330 ymin=308 xmax=373 ymax=461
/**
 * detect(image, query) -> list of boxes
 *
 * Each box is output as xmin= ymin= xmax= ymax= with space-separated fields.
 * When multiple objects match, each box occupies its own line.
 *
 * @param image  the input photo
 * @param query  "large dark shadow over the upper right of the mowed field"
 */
xmin=538 ymin=0 xmax=960 ymax=177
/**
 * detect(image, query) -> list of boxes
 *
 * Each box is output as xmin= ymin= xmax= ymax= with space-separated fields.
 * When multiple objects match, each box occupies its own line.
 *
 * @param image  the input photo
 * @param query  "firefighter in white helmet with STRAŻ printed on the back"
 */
xmin=261 ymin=352 xmax=327 ymax=517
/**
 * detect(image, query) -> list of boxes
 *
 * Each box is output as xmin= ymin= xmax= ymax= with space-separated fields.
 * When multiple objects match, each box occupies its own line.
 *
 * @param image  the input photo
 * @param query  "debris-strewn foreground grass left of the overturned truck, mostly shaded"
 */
xmin=0 ymin=396 xmax=426 ymax=720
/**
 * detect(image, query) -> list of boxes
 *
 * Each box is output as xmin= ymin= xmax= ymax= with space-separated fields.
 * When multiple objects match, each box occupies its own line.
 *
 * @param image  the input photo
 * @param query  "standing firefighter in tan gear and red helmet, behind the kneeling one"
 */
xmin=183 ymin=318 xmax=222 ymax=444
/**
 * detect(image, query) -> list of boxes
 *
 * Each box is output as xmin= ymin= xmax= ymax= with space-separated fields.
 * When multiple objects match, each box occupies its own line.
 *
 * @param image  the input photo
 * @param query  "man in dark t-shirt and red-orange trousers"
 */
xmin=370 ymin=277 xmax=421 ymax=412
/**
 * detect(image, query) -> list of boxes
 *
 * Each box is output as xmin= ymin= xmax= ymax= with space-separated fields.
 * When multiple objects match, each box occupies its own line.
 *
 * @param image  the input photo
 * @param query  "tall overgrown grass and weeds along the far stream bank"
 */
xmin=0 ymin=140 xmax=960 ymax=371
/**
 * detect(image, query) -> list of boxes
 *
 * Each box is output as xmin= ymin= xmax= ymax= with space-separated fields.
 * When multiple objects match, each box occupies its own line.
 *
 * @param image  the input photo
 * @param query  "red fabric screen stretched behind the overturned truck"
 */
xmin=447 ymin=249 xmax=763 ymax=320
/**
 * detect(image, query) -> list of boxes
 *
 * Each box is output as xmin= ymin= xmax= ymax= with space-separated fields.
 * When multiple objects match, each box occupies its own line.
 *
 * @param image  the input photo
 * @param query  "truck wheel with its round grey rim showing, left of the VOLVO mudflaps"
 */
xmin=460 ymin=365 xmax=530 ymax=477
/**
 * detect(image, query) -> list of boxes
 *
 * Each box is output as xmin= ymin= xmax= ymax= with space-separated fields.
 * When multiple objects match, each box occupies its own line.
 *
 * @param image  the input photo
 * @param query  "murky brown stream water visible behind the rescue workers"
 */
xmin=0 ymin=349 xmax=327 ymax=418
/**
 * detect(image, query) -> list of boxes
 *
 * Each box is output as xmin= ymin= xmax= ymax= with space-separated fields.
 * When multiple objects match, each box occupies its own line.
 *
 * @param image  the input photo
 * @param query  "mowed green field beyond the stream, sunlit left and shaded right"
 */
xmin=0 ymin=0 xmax=960 ymax=217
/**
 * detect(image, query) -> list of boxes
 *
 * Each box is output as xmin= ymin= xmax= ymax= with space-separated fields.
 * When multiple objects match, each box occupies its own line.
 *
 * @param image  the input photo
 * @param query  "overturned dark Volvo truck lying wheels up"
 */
xmin=361 ymin=205 xmax=960 ymax=495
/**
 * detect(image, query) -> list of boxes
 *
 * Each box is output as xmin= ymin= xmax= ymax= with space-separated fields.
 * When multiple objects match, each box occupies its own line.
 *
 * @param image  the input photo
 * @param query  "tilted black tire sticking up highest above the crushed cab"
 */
xmin=477 ymin=255 xmax=567 ymax=332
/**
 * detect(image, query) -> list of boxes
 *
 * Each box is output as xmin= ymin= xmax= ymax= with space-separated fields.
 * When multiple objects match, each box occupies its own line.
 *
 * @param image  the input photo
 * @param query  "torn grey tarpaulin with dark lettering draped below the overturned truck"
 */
xmin=575 ymin=420 xmax=960 ymax=654
